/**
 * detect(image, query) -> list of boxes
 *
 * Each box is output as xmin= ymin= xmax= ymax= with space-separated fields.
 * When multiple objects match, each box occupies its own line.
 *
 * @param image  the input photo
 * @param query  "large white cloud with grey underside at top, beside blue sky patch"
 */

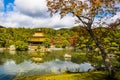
xmin=14 ymin=0 xmax=47 ymax=17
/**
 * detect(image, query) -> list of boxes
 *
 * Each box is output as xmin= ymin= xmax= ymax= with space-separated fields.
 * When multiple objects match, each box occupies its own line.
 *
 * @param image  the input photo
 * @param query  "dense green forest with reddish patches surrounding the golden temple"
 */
xmin=0 ymin=26 xmax=120 ymax=53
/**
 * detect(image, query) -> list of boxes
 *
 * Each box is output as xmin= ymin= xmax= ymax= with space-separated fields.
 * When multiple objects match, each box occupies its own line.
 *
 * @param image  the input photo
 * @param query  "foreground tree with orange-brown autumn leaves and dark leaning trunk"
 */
xmin=46 ymin=0 xmax=120 ymax=75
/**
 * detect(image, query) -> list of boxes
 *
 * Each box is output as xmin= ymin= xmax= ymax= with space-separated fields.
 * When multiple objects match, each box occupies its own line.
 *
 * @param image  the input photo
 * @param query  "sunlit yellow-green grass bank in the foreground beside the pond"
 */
xmin=13 ymin=71 xmax=107 ymax=80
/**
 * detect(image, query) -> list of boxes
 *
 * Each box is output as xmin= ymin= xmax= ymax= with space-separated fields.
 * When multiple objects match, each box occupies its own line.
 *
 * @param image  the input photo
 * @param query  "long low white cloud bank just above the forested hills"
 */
xmin=0 ymin=12 xmax=74 ymax=28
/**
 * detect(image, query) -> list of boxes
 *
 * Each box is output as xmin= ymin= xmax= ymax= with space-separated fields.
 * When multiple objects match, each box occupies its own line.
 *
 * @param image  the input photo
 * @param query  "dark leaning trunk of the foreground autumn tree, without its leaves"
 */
xmin=87 ymin=28 xmax=112 ymax=76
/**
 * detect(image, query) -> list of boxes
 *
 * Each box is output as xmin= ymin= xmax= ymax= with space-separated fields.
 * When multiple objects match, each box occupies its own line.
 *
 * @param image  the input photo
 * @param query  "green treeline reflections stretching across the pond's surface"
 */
xmin=0 ymin=49 xmax=116 ymax=67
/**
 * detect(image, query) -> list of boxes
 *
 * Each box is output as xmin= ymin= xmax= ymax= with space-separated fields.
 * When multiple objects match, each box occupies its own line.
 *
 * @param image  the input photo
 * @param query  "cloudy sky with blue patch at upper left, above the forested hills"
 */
xmin=0 ymin=0 xmax=120 ymax=29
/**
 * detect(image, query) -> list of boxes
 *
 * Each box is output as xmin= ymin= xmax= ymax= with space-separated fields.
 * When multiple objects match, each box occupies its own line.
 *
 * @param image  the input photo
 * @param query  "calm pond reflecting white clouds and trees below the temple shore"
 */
xmin=0 ymin=50 xmax=93 ymax=80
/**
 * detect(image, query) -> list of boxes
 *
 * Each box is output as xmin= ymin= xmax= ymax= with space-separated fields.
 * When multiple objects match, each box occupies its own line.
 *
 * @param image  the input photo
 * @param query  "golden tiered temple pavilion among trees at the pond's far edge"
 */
xmin=28 ymin=30 xmax=46 ymax=46
